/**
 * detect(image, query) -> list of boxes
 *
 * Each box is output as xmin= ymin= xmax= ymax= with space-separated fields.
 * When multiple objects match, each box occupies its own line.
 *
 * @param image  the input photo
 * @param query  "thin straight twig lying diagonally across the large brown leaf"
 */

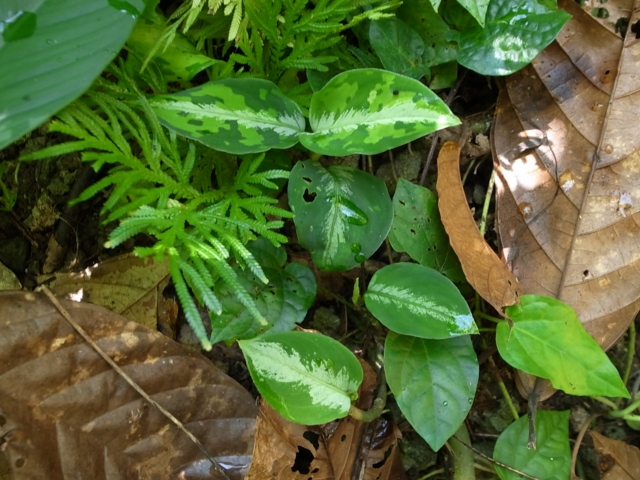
xmin=36 ymin=286 xmax=229 ymax=480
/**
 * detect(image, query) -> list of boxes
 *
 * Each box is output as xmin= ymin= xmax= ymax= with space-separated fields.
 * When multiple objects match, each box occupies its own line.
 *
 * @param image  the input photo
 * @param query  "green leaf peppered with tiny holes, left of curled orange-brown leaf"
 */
xmin=389 ymin=178 xmax=465 ymax=282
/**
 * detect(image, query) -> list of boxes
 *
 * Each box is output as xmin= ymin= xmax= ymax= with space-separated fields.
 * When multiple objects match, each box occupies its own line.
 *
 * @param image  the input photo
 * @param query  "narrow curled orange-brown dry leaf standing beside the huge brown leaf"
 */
xmin=436 ymin=142 xmax=519 ymax=313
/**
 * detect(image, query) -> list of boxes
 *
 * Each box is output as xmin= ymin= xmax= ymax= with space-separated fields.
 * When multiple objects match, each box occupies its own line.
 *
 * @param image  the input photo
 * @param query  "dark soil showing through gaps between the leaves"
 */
xmin=0 ymin=74 xmax=640 ymax=480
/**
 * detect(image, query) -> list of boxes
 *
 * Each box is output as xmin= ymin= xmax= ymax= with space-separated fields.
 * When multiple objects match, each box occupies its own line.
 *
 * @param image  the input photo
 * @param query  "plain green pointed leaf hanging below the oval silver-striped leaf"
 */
xmin=384 ymin=332 xmax=478 ymax=451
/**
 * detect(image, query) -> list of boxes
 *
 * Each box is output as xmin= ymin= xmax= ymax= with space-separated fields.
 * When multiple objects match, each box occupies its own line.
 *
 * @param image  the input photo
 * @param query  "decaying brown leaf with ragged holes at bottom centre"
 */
xmin=247 ymin=361 xmax=405 ymax=480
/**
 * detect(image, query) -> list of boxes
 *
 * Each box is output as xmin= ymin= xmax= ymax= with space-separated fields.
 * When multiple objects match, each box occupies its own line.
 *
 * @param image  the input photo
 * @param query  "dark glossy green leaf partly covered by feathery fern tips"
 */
xmin=211 ymin=238 xmax=316 ymax=344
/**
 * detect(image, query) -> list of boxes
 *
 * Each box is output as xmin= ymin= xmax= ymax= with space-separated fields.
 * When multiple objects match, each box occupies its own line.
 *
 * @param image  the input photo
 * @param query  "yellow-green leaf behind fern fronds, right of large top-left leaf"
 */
xmin=127 ymin=11 xmax=216 ymax=82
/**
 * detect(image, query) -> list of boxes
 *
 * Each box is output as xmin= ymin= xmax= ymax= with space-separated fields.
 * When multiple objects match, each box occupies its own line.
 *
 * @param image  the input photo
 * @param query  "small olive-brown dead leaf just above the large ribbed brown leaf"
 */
xmin=49 ymin=254 xmax=169 ymax=329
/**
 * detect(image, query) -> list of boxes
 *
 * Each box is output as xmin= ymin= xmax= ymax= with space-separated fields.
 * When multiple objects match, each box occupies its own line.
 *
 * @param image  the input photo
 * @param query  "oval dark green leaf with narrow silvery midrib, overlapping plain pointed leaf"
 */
xmin=364 ymin=263 xmax=478 ymax=339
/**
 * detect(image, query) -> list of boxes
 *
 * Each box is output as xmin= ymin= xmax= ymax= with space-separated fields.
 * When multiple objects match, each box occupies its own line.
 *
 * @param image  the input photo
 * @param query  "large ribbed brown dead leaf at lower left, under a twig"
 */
xmin=0 ymin=292 xmax=257 ymax=480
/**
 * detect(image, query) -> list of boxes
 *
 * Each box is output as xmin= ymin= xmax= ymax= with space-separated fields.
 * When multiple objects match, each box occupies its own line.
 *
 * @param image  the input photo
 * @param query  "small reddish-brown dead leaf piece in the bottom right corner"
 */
xmin=589 ymin=431 xmax=640 ymax=480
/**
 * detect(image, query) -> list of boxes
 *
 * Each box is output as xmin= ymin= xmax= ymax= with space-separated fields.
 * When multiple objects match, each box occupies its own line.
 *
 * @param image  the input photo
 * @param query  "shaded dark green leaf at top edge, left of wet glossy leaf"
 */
xmin=397 ymin=0 xmax=458 ymax=67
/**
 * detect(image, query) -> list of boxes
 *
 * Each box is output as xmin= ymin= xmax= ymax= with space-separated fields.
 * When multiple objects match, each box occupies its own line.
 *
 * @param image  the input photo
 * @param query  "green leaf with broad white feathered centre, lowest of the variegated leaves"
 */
xmin=238 ymin=332 xmax=363 ymax=425
